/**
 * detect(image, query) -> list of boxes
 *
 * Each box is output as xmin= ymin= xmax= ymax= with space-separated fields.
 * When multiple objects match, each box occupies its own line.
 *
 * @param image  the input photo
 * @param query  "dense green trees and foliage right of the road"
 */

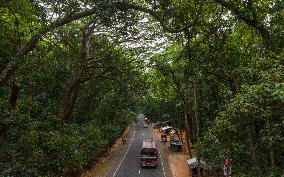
xmin=139 ymin=0 xmax=284 ymax=176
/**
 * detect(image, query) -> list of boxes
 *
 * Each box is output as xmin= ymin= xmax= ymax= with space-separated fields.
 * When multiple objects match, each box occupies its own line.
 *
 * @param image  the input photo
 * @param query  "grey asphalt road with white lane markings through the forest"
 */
xmin=110 ymin=115 xmax=172 ymax=177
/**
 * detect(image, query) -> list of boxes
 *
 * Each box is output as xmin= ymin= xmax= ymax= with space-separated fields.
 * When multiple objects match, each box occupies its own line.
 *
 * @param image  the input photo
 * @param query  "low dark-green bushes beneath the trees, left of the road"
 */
xmin=0 ymin=112 xmax=130 ymax=176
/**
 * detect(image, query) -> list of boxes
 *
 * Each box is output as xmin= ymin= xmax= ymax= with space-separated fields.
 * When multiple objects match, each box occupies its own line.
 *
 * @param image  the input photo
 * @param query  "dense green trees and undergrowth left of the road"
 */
xmin=0 ymin=1 xmax=145 ymax=176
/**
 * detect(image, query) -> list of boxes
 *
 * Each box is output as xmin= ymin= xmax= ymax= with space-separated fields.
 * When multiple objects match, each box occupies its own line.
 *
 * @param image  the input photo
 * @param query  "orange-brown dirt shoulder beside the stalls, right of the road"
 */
xmin=151 ymin=127 xmax=191 ymax=177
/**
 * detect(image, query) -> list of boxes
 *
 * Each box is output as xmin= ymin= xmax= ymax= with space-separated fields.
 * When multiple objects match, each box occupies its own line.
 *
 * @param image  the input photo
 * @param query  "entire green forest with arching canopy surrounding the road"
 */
xmin=0 ymin=0 xmax=284 ymax=177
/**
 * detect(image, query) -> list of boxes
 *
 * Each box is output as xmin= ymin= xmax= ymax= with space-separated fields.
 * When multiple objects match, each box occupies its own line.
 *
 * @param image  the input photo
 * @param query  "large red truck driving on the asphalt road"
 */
xmin=140 ymin=139 xmax=158 ymax=168
